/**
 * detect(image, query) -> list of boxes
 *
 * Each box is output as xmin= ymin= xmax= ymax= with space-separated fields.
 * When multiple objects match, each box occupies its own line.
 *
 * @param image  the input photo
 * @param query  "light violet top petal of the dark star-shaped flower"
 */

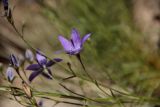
xmin=36 ymin=51 xmax=47 ymax=65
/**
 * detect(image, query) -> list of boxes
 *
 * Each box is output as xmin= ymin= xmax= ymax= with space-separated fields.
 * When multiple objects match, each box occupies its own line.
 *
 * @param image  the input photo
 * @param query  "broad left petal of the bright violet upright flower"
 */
xmin=58 ymin=36 xmax=73 ymax=53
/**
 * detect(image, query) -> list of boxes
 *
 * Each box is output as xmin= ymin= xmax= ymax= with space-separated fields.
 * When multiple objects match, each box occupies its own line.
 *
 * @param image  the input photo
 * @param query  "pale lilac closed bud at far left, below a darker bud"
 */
xmin=6 ymin=67 xmax=15 ymax=83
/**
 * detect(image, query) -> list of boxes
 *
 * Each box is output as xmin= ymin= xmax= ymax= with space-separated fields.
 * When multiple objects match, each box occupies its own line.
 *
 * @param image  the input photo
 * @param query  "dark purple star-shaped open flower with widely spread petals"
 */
xmin=27 ymin=51 xmax=62 ymax=82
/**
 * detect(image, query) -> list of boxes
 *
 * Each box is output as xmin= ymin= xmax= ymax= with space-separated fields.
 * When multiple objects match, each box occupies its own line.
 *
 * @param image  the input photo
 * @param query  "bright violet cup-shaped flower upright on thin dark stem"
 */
xmin=58 ymin=29 xmax=91 ymax=55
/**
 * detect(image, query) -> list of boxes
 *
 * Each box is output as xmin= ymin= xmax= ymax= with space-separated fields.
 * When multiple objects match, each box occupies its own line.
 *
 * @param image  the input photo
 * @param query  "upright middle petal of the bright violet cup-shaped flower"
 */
xmin=71 ymin=29 xmax=81 ymax=49
